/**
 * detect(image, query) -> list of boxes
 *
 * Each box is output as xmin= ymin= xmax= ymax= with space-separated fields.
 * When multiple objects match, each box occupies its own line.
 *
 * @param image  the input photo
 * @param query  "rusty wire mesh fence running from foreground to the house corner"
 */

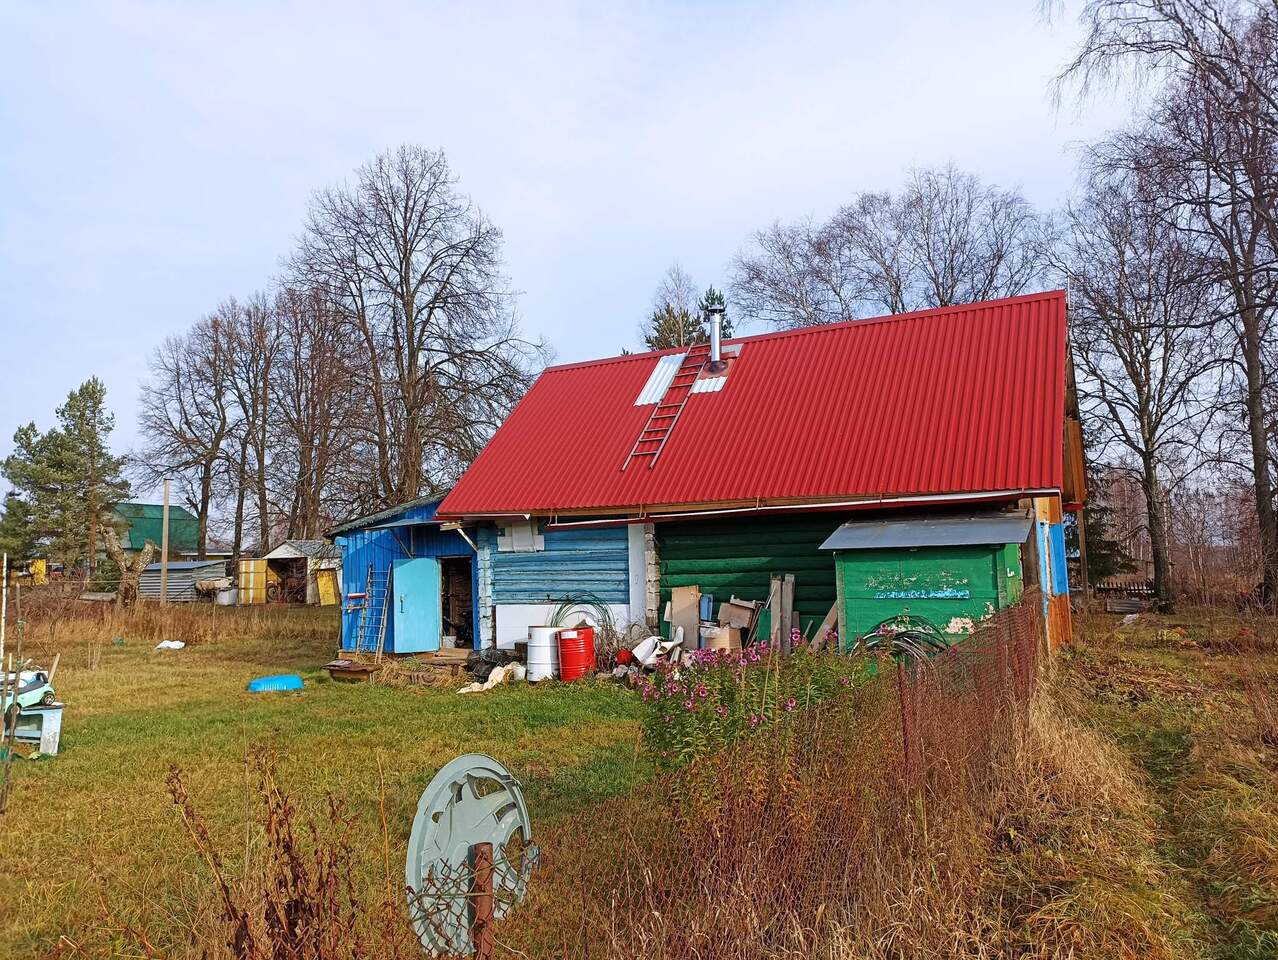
xmin=497 ymin=593 xmax=1043 ymax=960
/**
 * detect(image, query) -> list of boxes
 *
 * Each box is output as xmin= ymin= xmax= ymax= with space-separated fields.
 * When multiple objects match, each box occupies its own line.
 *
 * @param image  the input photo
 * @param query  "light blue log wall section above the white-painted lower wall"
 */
xmin=482 ymin=527 xmax=630 ymax=603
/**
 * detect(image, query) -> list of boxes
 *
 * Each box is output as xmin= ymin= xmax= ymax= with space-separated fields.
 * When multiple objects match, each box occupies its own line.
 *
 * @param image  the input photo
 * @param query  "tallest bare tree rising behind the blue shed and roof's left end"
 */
xmin=293 ymin=146 xmax=538 ymax=506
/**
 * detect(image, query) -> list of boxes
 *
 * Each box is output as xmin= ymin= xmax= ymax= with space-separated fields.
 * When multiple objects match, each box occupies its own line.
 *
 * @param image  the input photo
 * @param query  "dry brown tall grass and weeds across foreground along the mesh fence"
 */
xmin=62 ymin=601 xmax=1196 ymax=960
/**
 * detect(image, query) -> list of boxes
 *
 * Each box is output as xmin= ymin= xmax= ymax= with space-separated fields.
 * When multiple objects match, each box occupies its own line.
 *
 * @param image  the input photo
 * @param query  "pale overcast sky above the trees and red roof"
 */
xmin=0 ymin=0 xmax=1122 ymax=472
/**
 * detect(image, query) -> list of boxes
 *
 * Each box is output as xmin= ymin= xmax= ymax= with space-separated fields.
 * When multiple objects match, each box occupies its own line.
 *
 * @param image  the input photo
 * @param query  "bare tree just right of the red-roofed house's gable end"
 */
xmin=1047 ymin=161 xmax=1219 ymax=610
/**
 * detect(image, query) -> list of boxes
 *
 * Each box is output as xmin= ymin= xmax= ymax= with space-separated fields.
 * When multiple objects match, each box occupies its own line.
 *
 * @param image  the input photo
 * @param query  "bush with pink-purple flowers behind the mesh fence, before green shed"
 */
xmin=634 ymin=642 xmax=865 ymax=767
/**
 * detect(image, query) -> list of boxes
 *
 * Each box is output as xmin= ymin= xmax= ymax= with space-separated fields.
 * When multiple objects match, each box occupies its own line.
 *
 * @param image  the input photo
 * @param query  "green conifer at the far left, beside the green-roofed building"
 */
xmin=3 ymin=377 xmax=129 ymax=574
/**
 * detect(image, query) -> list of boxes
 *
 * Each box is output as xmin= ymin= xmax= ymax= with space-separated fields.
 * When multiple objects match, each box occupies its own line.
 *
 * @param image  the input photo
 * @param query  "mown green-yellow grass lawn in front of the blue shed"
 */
xmin=0 ymin=610 xmax=649 ymax=957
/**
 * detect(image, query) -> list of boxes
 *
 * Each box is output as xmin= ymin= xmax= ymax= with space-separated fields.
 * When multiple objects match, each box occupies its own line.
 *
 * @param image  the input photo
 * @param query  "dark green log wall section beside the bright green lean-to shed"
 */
xmin=657 ymin=513 xmax=846 ymax=641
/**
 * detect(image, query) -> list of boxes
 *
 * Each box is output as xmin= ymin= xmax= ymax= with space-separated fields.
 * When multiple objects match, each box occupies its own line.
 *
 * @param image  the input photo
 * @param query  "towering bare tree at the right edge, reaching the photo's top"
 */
xmin=1061 ymin=0 xmax=1278 ymax=603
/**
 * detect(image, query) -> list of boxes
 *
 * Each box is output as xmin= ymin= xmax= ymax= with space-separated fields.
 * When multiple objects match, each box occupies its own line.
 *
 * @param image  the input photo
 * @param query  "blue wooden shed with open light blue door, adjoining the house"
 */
xmin=331 ymin=497 xmax=481 ymax=653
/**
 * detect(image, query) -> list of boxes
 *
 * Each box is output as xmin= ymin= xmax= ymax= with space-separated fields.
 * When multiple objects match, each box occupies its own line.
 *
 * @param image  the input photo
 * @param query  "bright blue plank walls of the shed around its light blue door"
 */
xmin=336 ymin=502 xmax=479 ymax=653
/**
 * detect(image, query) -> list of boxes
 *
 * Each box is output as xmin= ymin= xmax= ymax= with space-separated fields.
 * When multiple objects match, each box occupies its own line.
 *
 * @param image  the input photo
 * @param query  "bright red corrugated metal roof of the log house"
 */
xmin=440 ymin=290 xmax=1066 ymax=516
